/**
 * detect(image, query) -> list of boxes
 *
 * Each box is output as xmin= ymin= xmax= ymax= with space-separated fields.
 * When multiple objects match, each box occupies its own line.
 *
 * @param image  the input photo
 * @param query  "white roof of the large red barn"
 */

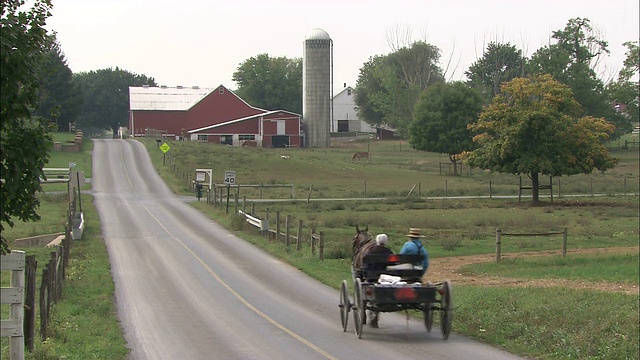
xmin=129 ymin=86 xmax=214 ymax=111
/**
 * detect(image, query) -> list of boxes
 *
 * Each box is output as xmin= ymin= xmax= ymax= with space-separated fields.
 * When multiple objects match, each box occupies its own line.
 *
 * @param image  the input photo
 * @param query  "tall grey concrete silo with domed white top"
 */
xmin=302 ymin=29 xmax=333 ymax=148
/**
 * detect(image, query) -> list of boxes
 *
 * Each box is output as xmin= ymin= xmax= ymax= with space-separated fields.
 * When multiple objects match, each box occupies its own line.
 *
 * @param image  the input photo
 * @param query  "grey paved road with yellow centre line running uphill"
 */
xmin=92 ymin=140 xmax=517 ymax=360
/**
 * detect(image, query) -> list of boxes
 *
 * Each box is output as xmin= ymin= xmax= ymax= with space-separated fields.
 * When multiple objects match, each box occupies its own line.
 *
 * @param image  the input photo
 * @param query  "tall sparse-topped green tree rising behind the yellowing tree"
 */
xmin=528 ymin=18 xmax=631 ymax=137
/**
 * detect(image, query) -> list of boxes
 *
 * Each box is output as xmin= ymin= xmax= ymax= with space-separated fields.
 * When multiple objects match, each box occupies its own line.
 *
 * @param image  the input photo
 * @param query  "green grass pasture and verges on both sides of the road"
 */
xmin=2 ymin=134 xmax=639 ymax=359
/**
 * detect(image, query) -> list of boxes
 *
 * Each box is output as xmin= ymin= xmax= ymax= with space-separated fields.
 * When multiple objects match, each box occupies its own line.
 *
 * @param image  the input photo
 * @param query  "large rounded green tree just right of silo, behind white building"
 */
xmin=354 ymin=41 xmax=444 ymax=136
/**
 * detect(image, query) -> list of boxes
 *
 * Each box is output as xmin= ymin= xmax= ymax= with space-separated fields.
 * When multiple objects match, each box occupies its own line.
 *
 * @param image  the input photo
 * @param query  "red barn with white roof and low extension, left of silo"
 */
xmin=129 ymin=85 xmax=303 ymax=148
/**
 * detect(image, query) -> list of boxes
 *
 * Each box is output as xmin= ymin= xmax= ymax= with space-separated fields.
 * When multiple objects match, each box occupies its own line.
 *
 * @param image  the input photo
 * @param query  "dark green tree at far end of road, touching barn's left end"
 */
xmin=74 ymin=67 xmax=157 ymax=133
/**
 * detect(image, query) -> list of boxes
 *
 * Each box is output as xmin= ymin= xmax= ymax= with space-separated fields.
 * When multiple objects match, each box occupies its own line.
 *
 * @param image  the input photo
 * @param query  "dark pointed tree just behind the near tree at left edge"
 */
xmin=36 ymin=37 xmax=82 ymax=131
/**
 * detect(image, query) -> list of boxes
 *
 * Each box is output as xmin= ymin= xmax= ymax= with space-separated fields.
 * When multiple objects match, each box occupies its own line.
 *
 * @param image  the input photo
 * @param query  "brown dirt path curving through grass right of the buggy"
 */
xmin=428 ymin=246 xmax=640 ymax=295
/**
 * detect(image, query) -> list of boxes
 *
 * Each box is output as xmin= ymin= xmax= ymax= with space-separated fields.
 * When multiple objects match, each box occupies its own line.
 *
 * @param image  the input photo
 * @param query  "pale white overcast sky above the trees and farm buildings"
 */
xmin=47 ymin=0 xmax=640 ymax=93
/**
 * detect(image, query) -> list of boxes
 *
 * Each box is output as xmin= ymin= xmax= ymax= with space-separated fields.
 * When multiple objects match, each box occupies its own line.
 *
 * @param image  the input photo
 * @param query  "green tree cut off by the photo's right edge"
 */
xmin=607 ymin=41 xmax=640 ymax=123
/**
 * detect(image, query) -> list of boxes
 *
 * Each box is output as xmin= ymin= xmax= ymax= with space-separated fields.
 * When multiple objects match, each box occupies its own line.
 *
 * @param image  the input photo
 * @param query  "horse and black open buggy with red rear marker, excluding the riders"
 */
xmin=339 ymin=229 xmax=453 ymax=339
